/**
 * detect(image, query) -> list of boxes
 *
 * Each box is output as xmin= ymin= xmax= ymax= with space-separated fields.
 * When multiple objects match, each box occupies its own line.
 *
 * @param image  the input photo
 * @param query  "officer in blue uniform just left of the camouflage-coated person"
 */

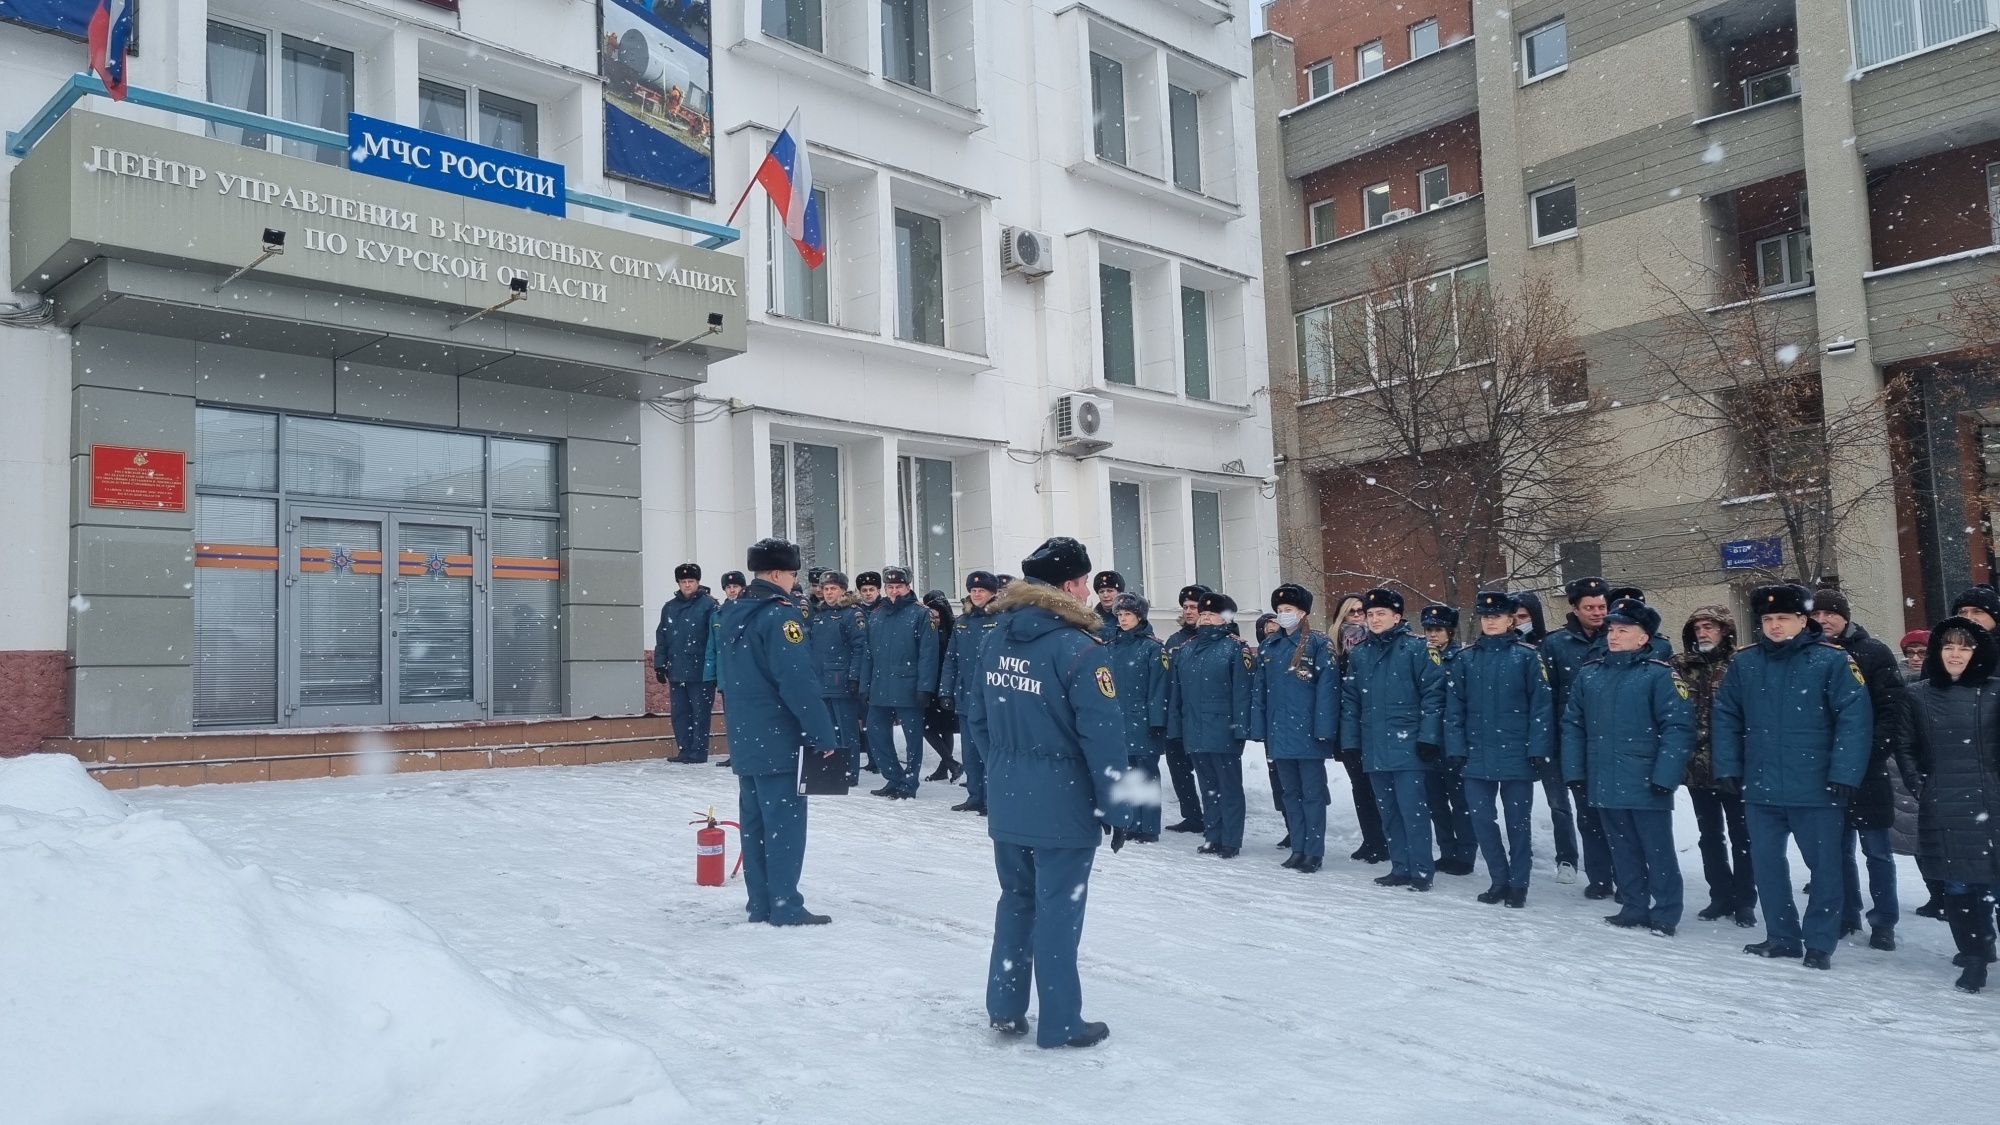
xmin=1562 ymin=597 xmax=1694 ymax=937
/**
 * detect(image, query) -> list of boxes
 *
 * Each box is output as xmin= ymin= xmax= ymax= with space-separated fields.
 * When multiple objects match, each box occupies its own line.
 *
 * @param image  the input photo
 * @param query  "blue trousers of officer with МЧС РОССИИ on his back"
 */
xmin=986 ymin=841 xmax=1098 ymax=1047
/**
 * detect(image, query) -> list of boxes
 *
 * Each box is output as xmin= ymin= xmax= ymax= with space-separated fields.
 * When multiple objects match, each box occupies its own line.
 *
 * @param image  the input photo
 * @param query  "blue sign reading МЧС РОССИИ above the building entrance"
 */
xmin=348 ymin=114 xmax=566 ymax=214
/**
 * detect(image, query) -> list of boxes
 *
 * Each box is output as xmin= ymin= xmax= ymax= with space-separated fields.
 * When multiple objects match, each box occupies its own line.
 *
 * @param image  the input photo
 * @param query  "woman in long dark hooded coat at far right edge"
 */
xmin=1896 ymin=617 xmax=2000 ymax=993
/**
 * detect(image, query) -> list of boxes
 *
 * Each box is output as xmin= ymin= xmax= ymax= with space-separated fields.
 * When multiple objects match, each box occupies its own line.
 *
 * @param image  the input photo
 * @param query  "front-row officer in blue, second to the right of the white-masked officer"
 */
xmin=1444 ymin=591 xmax=1556 ymax=909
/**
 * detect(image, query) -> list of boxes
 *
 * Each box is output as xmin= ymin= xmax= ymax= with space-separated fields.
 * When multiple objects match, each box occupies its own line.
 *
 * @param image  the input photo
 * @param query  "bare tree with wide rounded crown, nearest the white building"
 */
xmin=1274 ymin=240 xmax=1618 ymax=605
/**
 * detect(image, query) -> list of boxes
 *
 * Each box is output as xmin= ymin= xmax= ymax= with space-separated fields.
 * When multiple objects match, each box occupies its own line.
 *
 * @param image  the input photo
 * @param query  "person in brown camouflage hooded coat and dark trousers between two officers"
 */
xmin=1674 ymin=605 xmax=1756 ymax=929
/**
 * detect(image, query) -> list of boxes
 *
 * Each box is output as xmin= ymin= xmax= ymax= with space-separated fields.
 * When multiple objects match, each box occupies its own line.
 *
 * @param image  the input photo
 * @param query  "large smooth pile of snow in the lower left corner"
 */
xmin=0 ymin=755 xmax=692 ymax=1125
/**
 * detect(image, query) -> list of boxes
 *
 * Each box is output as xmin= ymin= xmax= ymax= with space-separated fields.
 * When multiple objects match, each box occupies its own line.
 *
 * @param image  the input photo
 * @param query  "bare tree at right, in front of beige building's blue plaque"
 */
xmin=1640 ymin=258 xmax=1900 ymax=585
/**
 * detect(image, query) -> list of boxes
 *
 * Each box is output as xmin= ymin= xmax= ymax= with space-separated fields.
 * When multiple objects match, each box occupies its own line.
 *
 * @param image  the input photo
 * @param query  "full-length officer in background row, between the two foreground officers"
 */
xmin=860 ymin=567 xmax=940 ymax=801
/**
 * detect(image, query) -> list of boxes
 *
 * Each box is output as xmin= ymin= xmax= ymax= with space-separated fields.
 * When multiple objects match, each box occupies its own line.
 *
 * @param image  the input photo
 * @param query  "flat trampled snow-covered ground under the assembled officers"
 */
xmin=43 ymin=747 xmax=2000 ymax=1125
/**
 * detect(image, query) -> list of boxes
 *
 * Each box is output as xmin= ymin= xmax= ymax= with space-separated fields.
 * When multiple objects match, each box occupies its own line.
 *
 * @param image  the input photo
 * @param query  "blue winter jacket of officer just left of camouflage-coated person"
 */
xmin=1562 ymin=649 xmax=1694 ymax=811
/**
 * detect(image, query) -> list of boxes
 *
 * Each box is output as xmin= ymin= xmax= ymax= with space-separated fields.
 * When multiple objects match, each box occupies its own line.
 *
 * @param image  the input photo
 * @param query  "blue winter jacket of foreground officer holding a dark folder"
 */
xmin=716 ymin=579 xmax=838 ymax=777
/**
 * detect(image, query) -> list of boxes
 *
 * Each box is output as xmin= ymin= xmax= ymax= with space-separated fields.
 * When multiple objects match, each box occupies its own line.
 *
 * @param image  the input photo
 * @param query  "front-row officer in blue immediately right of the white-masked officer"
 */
xmin=1340 ymin=587 xmax=1444 ymax=891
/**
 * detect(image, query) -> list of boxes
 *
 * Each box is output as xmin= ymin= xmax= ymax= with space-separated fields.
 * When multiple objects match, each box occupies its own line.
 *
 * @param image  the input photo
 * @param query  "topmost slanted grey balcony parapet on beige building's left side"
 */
xmin=1278 ymin=38 xmax=1480 ymax=180
